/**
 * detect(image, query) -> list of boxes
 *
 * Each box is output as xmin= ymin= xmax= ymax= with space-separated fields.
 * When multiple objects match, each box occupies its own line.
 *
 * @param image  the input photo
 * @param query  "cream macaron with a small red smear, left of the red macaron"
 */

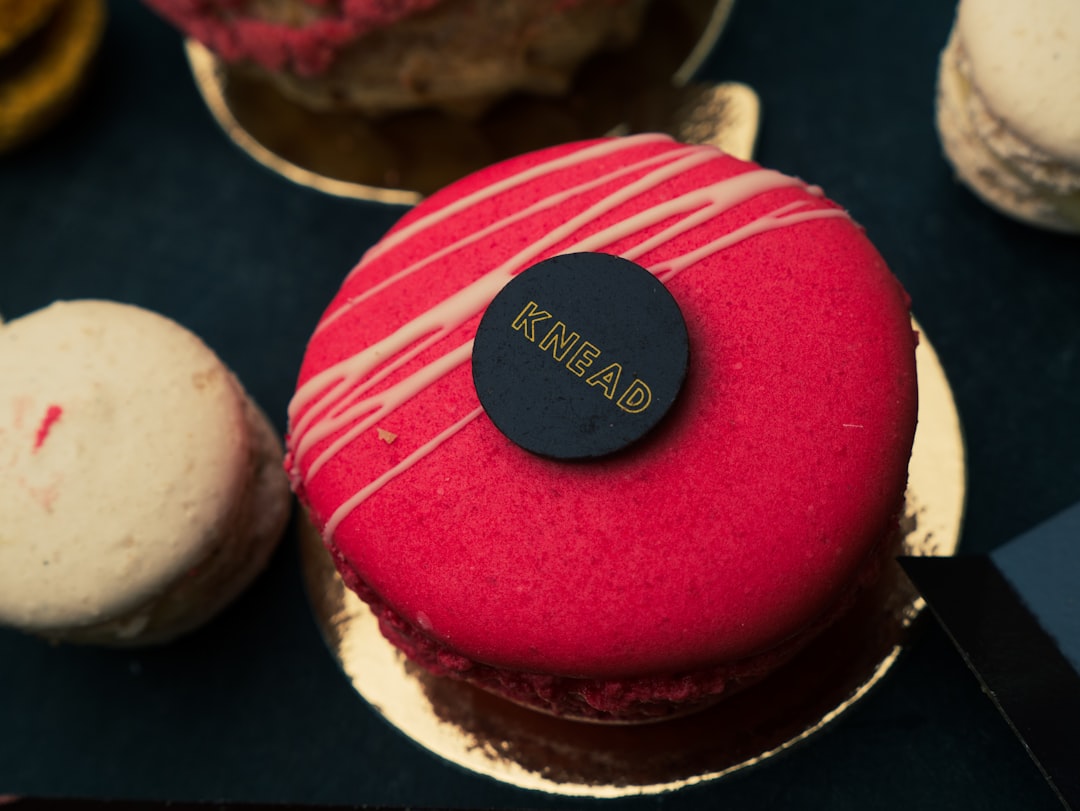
xmin=0 ymin=300 xmax=291 ymax=646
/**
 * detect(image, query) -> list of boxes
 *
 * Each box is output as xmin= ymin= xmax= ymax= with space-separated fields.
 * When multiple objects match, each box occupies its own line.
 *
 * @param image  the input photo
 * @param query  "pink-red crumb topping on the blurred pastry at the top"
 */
xmin=138 ymin=0 xmax=600 ymax=77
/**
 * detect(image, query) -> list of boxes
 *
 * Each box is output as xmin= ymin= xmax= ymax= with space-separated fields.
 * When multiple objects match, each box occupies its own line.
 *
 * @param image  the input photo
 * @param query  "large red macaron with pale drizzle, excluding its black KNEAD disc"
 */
xmin=286 ymin=135 xmax=917 ymax=720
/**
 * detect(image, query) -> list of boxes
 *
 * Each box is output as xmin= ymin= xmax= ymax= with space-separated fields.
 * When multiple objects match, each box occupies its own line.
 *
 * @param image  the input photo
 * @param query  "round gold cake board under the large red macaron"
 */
xmin=301 ymin=325 xmax=966 ymax=797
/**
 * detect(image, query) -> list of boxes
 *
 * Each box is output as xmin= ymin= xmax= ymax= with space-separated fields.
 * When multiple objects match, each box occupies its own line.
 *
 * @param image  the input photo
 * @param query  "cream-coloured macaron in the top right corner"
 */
xmin=936 ymin=0 xmax=1080 ymax=233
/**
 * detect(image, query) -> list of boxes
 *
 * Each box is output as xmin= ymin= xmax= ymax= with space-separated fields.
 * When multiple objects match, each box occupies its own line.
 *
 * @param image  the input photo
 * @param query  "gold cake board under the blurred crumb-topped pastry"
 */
xmin=186 ymin=0 xmax=759 ymax=205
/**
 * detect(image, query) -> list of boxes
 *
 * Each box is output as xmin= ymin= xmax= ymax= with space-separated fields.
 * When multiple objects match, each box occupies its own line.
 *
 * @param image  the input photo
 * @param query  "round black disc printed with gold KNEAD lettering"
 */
xmin=472 ymin=254 xmax=689 ymax=459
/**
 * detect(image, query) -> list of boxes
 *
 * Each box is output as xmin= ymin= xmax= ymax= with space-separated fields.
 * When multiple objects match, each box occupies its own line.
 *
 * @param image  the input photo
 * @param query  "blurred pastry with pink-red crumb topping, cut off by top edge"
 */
xmin=146 ymin=0 xmax=648 ymax=114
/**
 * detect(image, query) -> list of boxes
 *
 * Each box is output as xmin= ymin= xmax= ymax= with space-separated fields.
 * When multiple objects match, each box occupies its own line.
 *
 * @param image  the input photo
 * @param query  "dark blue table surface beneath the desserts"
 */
xmin=0 ymin=0 xmax=1080 ymax=809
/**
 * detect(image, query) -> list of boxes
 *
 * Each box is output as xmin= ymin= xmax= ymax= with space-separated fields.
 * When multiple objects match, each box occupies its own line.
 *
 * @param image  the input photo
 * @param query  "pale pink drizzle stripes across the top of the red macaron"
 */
xmin=289 ymin=137 xmax=848 ymax=540
